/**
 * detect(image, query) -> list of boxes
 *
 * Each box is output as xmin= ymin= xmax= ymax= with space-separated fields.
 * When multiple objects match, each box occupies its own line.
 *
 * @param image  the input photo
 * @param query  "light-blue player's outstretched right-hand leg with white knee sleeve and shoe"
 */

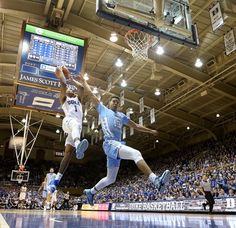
xmin=118 ymin=145 xmax=170 ymax=192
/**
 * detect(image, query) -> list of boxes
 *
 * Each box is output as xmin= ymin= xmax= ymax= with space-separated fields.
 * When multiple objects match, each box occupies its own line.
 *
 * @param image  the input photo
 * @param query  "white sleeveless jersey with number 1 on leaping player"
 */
xmin=62 ymin=96 xmax=83 ymax=122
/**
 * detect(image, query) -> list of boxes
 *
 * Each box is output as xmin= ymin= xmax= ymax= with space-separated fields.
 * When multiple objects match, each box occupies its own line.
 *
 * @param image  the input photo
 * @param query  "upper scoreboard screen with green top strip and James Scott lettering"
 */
xmin=18 ymin=24 xmax=85 ymax=89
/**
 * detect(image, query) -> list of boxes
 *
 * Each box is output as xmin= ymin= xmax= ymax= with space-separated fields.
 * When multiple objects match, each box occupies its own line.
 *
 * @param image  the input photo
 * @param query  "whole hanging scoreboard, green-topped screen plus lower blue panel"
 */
xmin=15 ymin=24 xmax=86 ymax=112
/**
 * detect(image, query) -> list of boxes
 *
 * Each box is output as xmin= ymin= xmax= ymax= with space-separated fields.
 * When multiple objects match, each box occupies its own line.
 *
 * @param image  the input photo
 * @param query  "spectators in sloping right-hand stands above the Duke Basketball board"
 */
xmin=95 ymin=133 xmax=236 ymax=203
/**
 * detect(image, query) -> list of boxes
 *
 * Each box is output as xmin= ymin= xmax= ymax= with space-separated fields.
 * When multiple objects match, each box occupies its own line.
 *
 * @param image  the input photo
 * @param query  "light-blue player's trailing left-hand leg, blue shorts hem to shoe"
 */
xmin=84 ymin=157 xmax=120 ymax=206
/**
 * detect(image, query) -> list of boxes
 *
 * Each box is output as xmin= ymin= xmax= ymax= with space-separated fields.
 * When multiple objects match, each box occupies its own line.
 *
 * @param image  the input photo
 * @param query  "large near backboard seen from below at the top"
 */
xmin=96 ymin=0 xmax=199 ymax=47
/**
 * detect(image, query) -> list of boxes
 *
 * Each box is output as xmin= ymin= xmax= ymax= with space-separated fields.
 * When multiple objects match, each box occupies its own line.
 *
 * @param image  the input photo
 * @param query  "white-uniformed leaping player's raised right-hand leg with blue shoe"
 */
xmin=65 ymin=118 xmax=89 ymax=159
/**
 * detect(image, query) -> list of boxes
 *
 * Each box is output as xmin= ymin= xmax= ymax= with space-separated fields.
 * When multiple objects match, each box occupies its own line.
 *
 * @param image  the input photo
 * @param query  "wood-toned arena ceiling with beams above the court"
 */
xmin=0 ymin=0 xmax=236 ymax=155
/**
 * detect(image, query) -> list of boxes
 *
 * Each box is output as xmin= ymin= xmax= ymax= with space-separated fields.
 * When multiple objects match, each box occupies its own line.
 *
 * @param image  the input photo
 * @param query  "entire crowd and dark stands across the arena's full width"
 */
xmin=0 ymin=133 xmax=236 ymax=207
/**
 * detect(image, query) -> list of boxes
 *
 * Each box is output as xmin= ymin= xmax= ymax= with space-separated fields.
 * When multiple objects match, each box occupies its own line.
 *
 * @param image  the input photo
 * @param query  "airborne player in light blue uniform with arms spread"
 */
xmin=79 ymin=75 xmax=170 ymax=205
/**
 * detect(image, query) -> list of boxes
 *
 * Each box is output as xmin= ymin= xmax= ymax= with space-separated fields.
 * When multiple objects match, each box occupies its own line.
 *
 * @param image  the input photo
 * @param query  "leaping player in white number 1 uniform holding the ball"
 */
xmin=47 ymin=67 xmax=88 ymax=193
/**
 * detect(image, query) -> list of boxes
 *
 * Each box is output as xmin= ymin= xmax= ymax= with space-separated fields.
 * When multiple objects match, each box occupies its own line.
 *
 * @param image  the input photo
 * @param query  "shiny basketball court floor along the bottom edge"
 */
xmin=0 ymin=210 xmax=236 ymax=228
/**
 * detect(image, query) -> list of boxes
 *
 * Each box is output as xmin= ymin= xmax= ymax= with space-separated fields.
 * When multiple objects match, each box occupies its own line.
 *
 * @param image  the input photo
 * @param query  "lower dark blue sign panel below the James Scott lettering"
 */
xmin=15 ymin=85 xmax=63 ymax=113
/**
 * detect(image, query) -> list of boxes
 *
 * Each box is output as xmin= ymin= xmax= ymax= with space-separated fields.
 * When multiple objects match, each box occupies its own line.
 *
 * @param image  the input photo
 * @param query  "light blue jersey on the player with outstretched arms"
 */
xmin=97 ymin=103 xmax=129 ymax=142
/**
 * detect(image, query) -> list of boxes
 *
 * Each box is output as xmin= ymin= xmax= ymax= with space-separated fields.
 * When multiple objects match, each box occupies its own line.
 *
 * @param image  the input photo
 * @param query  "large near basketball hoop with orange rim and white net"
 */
xmin=125 ymin=29 xmax=154 ymax=60
